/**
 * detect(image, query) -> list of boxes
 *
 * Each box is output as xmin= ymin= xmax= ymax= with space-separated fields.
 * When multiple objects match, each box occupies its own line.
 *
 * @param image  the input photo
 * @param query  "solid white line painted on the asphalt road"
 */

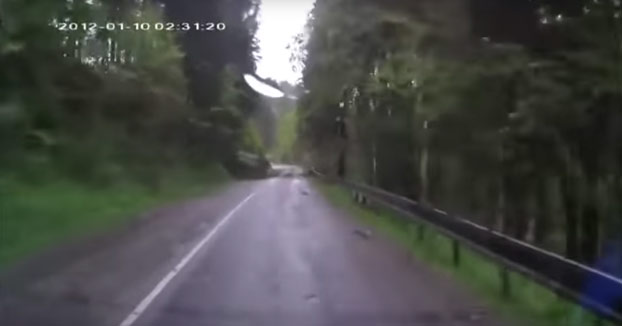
xmin=119 ymin=193 xmax=255 ymax=326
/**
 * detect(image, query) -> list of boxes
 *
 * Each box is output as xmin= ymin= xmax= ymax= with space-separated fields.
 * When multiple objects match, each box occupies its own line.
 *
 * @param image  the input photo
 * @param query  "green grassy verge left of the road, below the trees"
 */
xmin=0 ymin=166 xmax=228 ymax=266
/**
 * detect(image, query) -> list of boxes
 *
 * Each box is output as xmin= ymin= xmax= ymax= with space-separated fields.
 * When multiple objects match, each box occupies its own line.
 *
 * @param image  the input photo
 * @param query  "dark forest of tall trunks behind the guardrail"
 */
xmin=292 ymin=0 xmax=622 ymax=263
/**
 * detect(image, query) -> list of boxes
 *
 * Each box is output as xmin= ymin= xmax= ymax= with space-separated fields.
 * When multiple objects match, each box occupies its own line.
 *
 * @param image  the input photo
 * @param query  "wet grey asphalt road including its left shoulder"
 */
xmin=0 ymin=176 xmax=508 ymax=326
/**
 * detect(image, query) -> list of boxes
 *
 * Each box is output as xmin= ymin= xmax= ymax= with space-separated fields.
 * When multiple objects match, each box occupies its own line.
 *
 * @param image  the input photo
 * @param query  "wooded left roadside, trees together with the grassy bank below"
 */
xmin=0 ymin=0 xmax=270 ymax=261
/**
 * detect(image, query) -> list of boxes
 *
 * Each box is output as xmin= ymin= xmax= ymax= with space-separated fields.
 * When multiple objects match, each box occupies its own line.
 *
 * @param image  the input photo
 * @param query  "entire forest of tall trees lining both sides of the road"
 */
xmin=0 ymin=0 xmax=622 ymax=262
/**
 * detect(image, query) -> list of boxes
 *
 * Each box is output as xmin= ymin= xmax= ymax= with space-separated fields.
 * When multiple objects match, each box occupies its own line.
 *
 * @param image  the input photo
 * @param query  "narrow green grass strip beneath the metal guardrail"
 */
xmin=315 ymin=181 xmax=614 ymax=326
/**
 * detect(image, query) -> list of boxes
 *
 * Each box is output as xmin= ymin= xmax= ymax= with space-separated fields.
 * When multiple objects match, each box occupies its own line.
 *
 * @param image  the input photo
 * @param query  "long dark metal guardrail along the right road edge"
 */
xmin=311 ymin=170 xmax=622 ymax=325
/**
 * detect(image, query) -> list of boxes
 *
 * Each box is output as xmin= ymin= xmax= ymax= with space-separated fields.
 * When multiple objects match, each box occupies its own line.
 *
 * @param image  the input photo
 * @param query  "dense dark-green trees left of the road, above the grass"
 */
xmin=0 ymin=0 xmax=259 ymax=185
